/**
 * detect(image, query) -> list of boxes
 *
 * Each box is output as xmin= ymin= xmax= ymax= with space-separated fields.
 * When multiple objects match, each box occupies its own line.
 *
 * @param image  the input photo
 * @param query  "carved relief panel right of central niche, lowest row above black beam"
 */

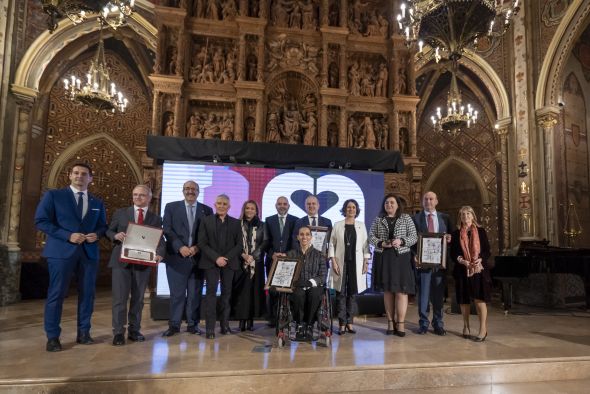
xmin=347 ymin=112 xmax=389 ymax=149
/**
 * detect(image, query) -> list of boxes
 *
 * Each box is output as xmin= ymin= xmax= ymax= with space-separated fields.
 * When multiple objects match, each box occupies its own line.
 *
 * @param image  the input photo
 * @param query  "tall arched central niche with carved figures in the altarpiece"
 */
xmin=266 ymin=71 xmax=318 ymax=145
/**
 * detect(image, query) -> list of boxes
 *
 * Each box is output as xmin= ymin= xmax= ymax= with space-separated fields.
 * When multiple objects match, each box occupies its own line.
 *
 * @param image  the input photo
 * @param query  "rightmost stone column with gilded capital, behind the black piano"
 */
xmin=536 ymin=107 xmax=559 ymax=245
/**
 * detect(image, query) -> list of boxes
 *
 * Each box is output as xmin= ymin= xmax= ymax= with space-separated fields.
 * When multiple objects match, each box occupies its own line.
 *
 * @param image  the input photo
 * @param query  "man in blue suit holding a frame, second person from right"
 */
xmin=414 ymin=191 xmax=452 ymax=336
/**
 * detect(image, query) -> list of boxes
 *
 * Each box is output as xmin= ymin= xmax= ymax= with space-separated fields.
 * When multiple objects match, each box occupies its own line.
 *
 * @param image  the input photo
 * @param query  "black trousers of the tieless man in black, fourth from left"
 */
xmin=205 ymin=267 xmax=239 ymax=331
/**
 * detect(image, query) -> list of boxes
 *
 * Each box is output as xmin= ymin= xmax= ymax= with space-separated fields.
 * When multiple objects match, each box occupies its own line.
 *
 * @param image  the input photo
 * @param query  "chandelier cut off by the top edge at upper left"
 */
xmin=41 ymin=0 xmax=135 ymax=33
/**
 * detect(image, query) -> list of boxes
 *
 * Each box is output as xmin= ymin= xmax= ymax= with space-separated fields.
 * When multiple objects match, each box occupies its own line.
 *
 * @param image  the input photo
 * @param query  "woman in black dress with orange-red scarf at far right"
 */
xmin=451 ymin=206 xmax=492 ymax=342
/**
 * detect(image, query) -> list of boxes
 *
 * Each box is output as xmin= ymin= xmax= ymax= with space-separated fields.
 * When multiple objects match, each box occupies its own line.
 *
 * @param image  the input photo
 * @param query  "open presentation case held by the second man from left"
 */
xmin=119 ymin=223 xmax=163 ymax=267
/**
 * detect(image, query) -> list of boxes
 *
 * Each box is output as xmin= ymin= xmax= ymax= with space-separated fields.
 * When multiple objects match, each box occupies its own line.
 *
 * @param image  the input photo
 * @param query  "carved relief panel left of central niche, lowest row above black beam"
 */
xmin=186 ymin=100 xmax=235 ymax=141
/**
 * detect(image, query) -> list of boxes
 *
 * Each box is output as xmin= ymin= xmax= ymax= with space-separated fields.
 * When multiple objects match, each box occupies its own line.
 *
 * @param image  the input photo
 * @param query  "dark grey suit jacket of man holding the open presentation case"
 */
xmin=106 ymin=205 xmax=166 ymax=268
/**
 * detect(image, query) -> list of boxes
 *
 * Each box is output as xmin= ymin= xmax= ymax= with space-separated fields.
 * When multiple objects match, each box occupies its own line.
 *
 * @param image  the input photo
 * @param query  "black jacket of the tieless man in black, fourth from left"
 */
xmin=197 ymin=215 xmax=244 ymax=270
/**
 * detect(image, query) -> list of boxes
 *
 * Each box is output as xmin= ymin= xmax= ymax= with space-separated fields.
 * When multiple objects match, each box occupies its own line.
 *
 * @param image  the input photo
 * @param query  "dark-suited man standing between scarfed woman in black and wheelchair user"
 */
xmin=264 ymin=196 xmax=297 ymax=326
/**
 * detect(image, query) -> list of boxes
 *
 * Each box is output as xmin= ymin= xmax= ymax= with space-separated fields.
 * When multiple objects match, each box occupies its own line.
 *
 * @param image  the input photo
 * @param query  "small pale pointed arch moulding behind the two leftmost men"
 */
xmin=47 ymin=133 xmax=143 ymax=189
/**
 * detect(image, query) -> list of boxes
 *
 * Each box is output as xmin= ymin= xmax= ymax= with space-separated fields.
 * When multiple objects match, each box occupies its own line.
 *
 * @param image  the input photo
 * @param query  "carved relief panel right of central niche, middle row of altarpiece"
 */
xmin=348 ymin=53 xmax=389 ymax=97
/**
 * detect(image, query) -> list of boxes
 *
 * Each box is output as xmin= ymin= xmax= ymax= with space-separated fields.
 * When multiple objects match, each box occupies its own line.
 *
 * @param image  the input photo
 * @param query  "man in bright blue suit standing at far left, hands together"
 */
xmin=35 ymin=163 xmax=107 ymax=352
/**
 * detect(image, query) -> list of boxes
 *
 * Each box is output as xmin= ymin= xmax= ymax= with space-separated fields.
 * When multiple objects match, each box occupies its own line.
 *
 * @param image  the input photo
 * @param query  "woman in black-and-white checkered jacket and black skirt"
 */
xmin=369 ymin=194 xmax=418 ymax=337
